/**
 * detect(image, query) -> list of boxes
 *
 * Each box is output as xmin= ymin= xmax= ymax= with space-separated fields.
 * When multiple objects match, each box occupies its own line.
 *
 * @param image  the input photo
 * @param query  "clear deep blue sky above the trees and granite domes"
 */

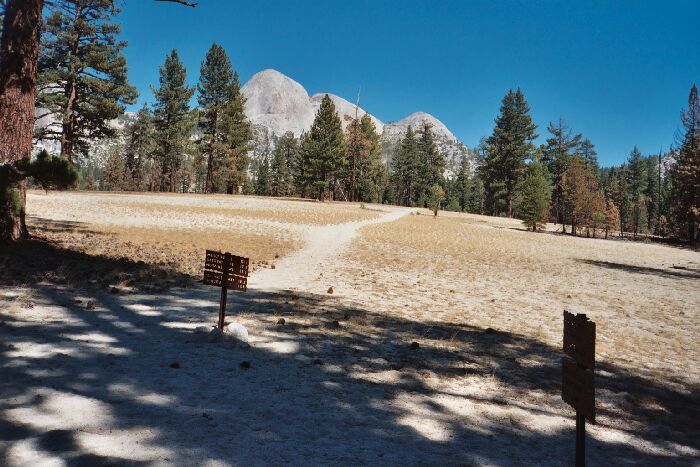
xmin=120 ymin=0 xmax=700 ymax=165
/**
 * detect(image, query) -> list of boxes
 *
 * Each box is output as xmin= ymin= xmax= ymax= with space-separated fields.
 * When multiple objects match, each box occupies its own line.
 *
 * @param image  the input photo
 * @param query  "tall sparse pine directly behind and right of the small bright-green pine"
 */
xmin=542 ymin=118 xmax=590 ymax=231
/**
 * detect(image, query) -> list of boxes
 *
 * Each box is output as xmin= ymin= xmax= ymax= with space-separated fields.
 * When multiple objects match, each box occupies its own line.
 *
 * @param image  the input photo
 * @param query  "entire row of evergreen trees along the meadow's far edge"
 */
xmin=24 ymin=0 xmax=700 ymax=245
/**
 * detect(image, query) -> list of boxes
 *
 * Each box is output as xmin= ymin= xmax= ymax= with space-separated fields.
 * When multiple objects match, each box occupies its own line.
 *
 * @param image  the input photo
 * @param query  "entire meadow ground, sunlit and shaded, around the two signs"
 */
xmin=0 ymin=193 xmax=700 ymax=465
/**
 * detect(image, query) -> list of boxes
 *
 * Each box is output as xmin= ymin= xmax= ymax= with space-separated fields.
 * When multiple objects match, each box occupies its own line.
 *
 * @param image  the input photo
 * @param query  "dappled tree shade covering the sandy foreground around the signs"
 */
xmin=0 ymin=241 xmax=700 ymax=465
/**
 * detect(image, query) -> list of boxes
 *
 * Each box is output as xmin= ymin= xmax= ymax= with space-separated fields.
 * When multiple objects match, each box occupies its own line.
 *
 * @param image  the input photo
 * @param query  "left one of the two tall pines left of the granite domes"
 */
xmin=152 ymin=50 xmax=194 ymax=192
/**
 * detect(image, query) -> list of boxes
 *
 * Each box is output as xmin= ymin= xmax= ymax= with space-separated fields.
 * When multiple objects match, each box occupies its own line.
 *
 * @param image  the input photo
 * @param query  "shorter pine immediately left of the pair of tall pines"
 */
xmin=124 ymin=104 xmax=154 ymax=191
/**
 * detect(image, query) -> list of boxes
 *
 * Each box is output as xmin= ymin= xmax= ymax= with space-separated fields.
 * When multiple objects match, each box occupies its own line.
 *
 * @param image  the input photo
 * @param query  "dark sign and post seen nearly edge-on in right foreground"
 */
xmin=561 ymin=310 xmax=595 ymax=467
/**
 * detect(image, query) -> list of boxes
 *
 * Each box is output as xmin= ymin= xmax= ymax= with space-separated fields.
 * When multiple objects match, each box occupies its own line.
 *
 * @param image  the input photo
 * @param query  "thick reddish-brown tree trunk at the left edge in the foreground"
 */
xmin=0 ymin=0 xmax=44 ymax=241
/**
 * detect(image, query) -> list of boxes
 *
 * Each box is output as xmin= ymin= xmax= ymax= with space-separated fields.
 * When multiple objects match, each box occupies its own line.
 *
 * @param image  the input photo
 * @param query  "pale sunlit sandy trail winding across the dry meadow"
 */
xmin=248 ymin=208 xmax=411 ymax=291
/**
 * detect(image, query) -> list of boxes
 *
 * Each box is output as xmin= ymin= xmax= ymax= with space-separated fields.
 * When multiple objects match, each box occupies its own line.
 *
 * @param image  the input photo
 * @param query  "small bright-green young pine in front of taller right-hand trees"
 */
xmin=518 ymin=161 xmax=552 ymax=232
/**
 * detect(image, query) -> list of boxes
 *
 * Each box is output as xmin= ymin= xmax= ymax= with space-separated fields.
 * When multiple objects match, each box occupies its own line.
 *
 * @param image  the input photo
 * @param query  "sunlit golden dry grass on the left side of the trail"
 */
xmin=28 ymin=191 xmax=378 ymax=276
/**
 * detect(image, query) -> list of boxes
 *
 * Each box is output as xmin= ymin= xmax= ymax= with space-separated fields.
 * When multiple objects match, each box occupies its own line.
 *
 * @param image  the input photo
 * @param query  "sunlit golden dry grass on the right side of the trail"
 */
xmin=340 ymin=215 xmax=700 ymax=384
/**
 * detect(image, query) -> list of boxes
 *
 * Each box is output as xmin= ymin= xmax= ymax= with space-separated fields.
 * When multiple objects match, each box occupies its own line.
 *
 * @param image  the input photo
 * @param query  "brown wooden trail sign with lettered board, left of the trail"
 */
xmin=202 ymin=250 xmax=249 ymax=329
